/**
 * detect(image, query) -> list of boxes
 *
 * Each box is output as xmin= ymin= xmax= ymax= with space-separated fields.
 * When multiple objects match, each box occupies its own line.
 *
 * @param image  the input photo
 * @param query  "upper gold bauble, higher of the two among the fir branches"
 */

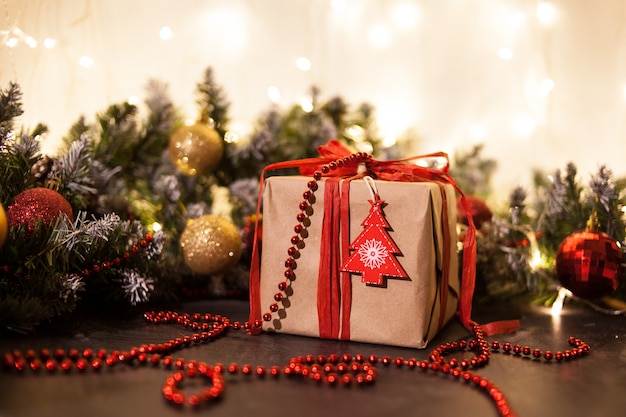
xmin=169 ymin=123 xmax=224 ymax=176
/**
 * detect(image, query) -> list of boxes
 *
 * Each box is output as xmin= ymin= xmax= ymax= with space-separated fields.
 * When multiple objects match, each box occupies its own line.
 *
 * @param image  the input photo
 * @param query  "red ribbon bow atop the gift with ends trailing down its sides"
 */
xmin=250 ymin=140 xmax=519 ymax=334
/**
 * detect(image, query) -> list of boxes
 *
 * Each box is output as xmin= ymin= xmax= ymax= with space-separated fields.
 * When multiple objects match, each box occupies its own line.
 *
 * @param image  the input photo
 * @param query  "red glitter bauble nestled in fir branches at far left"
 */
xmin=7 ymin=188 xmax=73 ymax=232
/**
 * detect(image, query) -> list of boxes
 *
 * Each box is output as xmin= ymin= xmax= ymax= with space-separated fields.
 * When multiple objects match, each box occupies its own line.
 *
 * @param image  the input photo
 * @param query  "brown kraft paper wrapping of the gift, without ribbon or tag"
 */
xmin=260 ymin=176 xmax=460 ymax=348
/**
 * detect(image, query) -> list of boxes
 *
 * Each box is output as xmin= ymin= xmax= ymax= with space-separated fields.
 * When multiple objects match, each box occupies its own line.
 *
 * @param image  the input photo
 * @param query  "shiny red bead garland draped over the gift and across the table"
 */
xmin=2 ymin=153 xmax=591 ymax=417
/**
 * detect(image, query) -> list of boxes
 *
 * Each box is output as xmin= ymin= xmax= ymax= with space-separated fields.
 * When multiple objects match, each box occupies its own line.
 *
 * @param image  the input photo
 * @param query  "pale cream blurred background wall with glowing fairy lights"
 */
xmin=0 ymin=0 xmax=626 ymax=205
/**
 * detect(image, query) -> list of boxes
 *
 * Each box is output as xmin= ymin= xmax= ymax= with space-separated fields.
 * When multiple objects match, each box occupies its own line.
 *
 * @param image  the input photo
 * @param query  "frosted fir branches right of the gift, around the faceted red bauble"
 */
xmin=477 ymin=163 xmax=626 ymax=303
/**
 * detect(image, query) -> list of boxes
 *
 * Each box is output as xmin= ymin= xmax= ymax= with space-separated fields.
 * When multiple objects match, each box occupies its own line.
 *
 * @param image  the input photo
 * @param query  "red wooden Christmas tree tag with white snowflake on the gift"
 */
xmin=341 ymin=194 xmax=409 ymax=286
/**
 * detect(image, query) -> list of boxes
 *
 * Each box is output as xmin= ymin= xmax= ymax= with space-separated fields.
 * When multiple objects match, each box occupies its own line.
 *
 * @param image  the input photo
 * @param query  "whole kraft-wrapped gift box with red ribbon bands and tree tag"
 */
xmin=251 ymin=169 xmax=460 ymax=348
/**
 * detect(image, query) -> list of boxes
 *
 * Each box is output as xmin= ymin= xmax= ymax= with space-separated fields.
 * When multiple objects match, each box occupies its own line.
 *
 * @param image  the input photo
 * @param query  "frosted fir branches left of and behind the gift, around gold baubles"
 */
xmin=0 ymin=68 xmax=390 ymax=331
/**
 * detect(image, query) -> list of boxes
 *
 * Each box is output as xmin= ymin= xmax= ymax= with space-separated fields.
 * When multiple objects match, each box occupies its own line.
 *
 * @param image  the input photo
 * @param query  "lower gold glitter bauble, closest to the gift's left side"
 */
xmin=180 ymin=214 xmax=242 ymax=275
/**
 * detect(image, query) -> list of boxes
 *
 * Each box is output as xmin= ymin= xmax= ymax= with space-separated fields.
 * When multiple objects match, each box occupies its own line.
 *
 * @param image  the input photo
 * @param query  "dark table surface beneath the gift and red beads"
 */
xmin=0 ymin=300 xmax=626 ymax=417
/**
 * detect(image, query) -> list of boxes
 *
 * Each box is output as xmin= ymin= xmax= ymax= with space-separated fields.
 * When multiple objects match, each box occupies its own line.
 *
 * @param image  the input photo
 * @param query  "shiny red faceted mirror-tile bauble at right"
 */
xmin=556 ymin=230 xmax=622 ymax=299
